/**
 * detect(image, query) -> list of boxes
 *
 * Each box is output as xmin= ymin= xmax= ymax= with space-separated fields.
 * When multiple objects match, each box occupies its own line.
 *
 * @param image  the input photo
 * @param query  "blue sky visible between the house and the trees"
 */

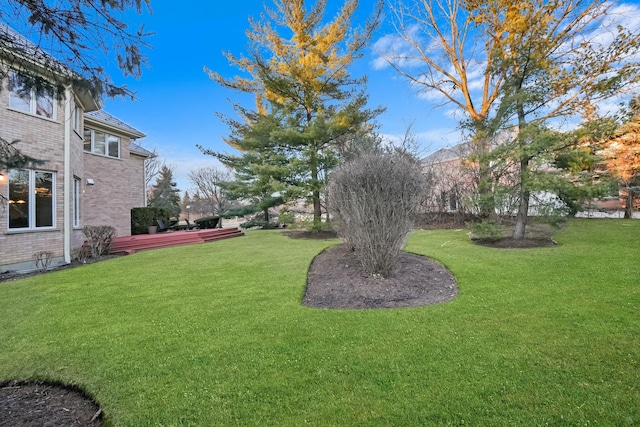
xmin=99 ymin=0 xmax=458 ymax=191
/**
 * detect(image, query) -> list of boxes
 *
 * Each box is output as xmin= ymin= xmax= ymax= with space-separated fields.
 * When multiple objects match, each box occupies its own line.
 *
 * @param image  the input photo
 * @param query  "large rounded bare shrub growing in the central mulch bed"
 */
xmin=329 ymin=152 xmax=424 ymax=277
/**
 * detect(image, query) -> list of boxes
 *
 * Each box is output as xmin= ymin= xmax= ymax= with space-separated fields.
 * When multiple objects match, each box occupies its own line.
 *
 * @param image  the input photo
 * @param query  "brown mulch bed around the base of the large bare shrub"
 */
xmin=302 ymin=244 xmax=458 ymax=308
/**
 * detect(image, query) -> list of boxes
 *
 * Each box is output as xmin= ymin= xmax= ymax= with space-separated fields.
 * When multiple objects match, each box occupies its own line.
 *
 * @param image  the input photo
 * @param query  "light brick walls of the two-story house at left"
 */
xmin=0 ymin=68 xmax=144 ymax=273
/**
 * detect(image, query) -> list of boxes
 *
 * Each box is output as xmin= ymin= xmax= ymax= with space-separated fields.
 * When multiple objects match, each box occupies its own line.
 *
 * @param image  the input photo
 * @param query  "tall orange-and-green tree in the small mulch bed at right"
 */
xmin=474 ymin=0 xmax=640 ymax=239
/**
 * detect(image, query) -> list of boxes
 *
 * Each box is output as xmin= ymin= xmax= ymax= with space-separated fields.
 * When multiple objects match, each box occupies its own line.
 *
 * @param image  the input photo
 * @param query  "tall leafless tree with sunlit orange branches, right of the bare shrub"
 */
xmin=374 ymin=0 xmax=516 ymax=218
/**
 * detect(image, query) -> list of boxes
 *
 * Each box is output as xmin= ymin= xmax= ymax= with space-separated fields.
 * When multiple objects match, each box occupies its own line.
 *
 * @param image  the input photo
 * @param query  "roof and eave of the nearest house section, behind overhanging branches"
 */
xmin=0 ymin=22 xmax=100 ymax=111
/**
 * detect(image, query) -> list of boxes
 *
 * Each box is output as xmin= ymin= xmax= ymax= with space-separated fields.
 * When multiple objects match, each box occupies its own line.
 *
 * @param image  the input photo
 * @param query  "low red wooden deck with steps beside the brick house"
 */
xmin=111 ymin=228 xmax=244 ymax=254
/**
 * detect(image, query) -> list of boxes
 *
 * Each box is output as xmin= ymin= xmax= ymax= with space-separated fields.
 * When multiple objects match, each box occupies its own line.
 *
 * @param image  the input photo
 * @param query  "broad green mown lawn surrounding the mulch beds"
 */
xmin=0 ymin=220 xmax=640 ymax=426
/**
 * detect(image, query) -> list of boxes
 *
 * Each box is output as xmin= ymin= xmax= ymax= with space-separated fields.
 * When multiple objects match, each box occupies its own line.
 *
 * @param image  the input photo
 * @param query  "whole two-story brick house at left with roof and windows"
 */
xmin=0 ymin=23 xmax=151 ymax=272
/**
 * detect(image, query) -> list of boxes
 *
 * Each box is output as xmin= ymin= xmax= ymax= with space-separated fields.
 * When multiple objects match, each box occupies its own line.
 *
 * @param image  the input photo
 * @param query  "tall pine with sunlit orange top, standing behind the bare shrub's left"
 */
xmin=205 ymin=0 xmax=382 ymax=227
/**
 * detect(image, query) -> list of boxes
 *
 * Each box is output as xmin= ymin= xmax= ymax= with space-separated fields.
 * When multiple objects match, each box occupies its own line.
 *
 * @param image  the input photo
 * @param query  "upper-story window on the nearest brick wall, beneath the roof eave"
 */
xmin=9 ymin=71 xmax=55 ymax=119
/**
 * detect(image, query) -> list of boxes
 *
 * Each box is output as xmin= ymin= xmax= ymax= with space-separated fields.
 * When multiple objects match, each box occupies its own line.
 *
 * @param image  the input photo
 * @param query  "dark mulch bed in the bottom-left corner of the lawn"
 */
xmin=0 ymin=380 xmax=103 ymax=427
